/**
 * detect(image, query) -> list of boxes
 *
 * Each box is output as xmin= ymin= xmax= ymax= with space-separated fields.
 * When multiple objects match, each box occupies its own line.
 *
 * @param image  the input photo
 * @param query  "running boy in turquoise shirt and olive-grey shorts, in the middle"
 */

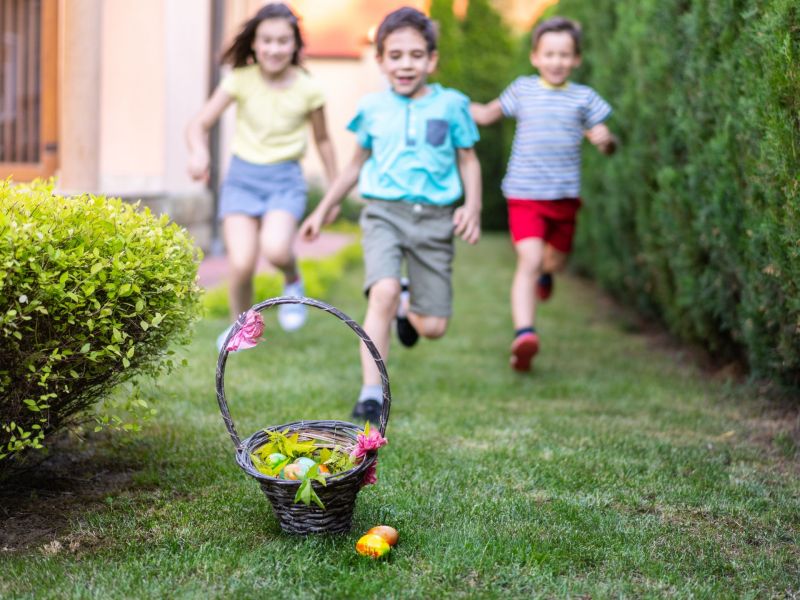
xmin=300 ymin=7 xmax=481 ymax=423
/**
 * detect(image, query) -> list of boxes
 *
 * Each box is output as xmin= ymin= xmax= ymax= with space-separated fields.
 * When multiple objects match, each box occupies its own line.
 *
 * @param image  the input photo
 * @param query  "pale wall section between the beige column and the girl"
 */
xmin=100 ymin=0 xmax=210 ymax=195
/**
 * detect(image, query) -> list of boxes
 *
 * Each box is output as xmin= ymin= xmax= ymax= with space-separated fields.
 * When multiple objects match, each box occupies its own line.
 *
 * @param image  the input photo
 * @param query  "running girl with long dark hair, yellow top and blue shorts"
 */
xmin=186 ymin=3 xmax=336 ymax=347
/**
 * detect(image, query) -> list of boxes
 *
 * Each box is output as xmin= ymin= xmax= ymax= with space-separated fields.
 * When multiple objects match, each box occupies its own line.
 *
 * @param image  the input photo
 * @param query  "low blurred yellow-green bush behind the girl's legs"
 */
xmin=203 ymin=237 xmax=361 ymax=318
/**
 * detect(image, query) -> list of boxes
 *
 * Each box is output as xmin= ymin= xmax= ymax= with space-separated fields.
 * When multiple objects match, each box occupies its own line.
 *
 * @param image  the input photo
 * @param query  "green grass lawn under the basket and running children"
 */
xmin=0 ymin=236 xmax=800 ymax=598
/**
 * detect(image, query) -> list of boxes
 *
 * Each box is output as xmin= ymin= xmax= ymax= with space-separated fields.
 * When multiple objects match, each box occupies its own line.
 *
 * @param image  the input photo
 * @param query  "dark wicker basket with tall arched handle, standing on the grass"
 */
xmin=211 ymin=296 xmax=392 ymax=534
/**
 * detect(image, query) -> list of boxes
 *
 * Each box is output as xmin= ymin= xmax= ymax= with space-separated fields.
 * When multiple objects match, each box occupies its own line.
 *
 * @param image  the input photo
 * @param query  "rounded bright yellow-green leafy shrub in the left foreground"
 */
xmin=0 ymin=181 xmax=200 ymax=470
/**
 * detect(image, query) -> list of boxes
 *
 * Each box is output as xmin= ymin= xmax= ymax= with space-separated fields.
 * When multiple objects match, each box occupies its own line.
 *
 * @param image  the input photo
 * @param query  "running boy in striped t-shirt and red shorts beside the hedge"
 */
xmin=471 ymin=17 xmax=617 ymax=371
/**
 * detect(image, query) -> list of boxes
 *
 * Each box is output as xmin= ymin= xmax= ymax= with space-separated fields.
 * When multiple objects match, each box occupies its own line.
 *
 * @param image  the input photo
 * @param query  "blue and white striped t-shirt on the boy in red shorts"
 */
xmin=500 ymin=75 xmax=611 ymax=200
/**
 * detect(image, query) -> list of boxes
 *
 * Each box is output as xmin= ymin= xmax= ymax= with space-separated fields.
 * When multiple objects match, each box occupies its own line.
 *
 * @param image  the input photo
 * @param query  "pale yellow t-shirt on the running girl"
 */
xmin=221 ymin=64 xmax=325 ymax=164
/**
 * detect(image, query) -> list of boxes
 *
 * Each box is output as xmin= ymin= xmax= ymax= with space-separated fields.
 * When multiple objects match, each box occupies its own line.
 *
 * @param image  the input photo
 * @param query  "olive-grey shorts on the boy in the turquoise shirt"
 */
xmin=360 ymin=200 xmax=455 ymax=317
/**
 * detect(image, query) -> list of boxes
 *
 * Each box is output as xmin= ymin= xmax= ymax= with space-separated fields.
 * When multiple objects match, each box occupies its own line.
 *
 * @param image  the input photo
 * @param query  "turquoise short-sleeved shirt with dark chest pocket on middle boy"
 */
xmin=347 ymin=84 xmax=479 ymax=206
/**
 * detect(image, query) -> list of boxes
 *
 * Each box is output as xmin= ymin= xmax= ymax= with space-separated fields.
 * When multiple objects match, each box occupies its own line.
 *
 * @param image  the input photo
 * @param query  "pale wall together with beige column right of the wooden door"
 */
xmin=58 ymin=0 xmax=210 ymax=197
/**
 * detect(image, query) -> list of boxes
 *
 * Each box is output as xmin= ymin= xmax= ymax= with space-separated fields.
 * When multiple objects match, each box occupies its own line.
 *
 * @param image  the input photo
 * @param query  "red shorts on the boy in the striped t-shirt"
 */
xmin=508 ymin=198 xmax=581 ymax=253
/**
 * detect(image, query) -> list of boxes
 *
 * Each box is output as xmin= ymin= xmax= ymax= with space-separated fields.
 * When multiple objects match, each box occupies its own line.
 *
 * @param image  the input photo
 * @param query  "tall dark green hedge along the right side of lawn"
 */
xmin=559 ymin=0 xmax=800 ymax=386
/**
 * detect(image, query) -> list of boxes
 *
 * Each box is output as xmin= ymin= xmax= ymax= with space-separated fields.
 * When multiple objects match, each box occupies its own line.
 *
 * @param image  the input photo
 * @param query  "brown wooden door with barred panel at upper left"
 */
xmin=0 ymin=0 xmax=58 ymax=181
